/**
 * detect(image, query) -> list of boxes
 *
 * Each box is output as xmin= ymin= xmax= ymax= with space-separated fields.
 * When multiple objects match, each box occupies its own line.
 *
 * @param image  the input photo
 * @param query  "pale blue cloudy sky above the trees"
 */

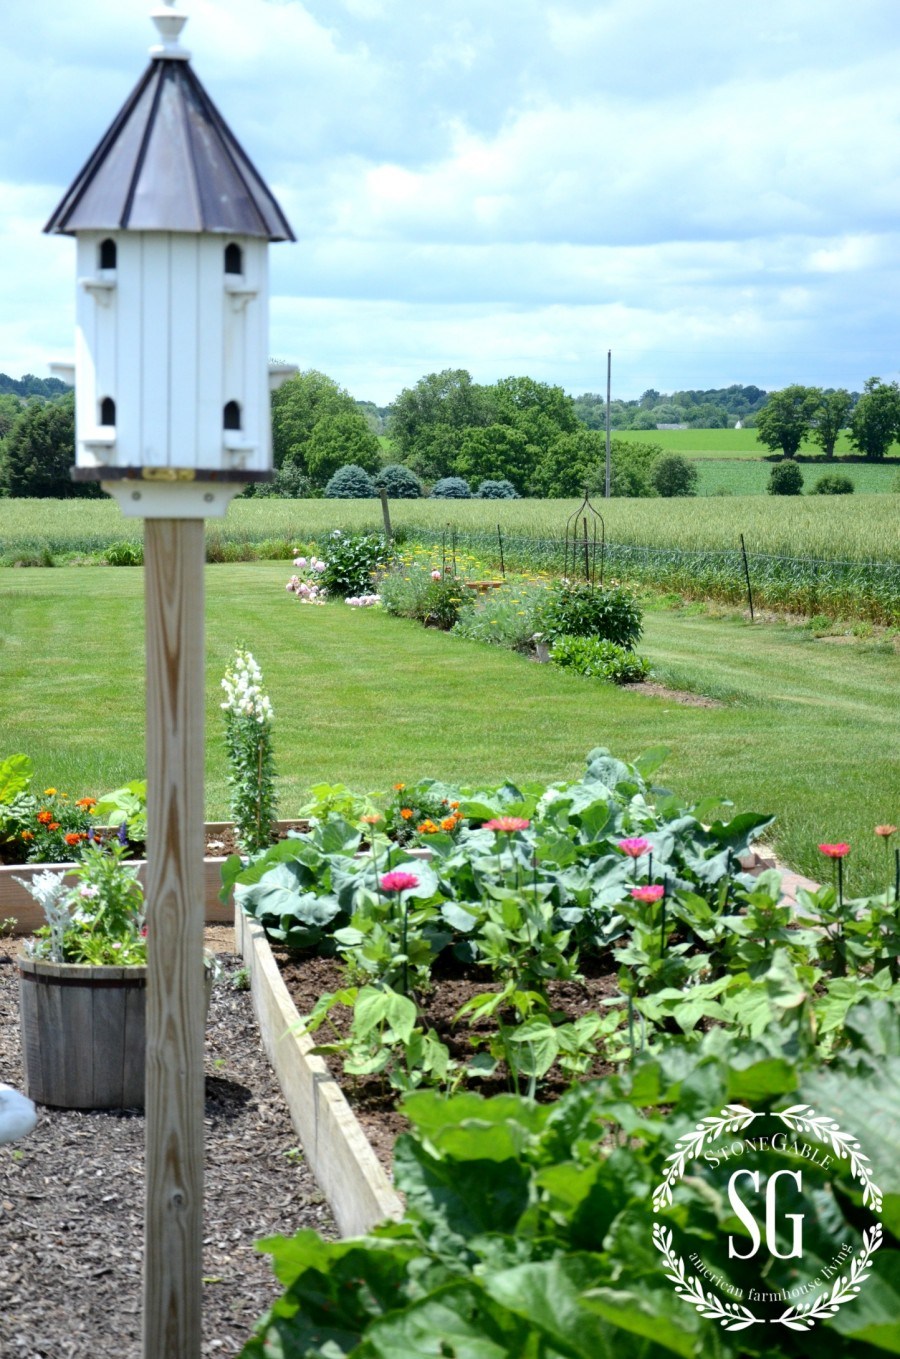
xmin=0 ymin=0 xmax=900 ymax=404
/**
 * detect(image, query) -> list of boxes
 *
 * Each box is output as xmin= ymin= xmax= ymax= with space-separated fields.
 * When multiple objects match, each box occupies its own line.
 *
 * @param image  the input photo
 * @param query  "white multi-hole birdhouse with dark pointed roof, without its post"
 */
xmin=45 ymin=0 xmax=294 ymax=519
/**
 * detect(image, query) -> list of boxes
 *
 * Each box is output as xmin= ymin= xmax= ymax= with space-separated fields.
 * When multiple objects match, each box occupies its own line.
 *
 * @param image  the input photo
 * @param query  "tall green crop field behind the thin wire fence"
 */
xmin=0 ymin=494 xmax=900 ymax=624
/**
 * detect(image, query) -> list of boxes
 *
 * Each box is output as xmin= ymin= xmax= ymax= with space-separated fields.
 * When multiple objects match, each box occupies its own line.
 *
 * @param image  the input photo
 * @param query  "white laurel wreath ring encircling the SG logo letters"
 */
xmin=653 ymin=1105 xmax=884 ymax=1330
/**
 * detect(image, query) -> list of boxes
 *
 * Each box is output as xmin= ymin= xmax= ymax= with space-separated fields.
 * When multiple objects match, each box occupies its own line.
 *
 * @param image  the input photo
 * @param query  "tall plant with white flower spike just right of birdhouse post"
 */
xmin=222 ymin=647 xmax=277 ymax=853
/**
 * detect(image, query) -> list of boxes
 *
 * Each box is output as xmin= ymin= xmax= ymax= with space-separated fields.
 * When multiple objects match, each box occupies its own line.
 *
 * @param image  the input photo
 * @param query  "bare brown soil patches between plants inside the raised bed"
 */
xmin=273 ymin=949 xmax=619 ymax=1174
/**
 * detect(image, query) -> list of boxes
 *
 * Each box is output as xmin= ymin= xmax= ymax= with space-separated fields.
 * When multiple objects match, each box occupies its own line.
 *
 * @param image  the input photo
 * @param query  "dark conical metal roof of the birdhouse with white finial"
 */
xmin=44 ymin=0 xmax=295 ymax=241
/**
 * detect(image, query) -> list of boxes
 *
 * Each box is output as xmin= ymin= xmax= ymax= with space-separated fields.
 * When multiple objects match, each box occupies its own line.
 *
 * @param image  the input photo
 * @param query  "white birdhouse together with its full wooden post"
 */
xmin=46 ymin=0 xmax=294 ymax=1359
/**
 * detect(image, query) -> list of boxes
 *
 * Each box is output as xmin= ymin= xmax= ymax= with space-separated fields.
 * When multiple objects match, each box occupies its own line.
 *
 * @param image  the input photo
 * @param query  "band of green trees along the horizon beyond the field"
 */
xmin=0 ymin=368 xmax=900 ymax=497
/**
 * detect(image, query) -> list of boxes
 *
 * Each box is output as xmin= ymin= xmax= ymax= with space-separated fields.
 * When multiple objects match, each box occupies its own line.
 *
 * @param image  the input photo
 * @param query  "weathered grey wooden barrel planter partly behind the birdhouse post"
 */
xmin=18 ymin=955 xmax=212 ymax=1109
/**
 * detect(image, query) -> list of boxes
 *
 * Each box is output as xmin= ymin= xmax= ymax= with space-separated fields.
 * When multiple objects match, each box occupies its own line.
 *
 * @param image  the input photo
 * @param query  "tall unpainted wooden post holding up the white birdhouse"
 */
xmin=143 ymin=519 xmax=204 ymax=1359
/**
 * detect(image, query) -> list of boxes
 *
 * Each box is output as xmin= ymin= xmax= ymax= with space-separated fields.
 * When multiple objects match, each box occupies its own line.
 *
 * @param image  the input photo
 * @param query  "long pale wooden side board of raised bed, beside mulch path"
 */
xmin=234 ymin=911 xmax=404 ymax=1237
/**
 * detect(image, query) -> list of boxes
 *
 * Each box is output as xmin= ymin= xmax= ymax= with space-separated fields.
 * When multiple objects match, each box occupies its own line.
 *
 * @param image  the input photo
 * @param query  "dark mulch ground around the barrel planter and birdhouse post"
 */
xmin=0 ymin=927 xmax=336 ymax=1359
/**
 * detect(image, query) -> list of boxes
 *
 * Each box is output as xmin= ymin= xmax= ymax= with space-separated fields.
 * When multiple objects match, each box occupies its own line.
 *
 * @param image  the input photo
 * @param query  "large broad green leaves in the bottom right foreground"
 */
xmin=242 ymin=1054 xmax=900 ymax=1359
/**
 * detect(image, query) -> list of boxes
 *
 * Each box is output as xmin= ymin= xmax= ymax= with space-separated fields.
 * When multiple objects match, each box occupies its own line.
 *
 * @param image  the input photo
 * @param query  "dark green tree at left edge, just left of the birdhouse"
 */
xmin=3 ymin=395 xmax=102 ymax=500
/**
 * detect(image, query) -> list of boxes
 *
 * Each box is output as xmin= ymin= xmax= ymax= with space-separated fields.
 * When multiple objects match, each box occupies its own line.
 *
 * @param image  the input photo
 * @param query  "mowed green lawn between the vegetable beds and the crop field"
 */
xmin=0 ymin=563 xmax=900 ymax=892
